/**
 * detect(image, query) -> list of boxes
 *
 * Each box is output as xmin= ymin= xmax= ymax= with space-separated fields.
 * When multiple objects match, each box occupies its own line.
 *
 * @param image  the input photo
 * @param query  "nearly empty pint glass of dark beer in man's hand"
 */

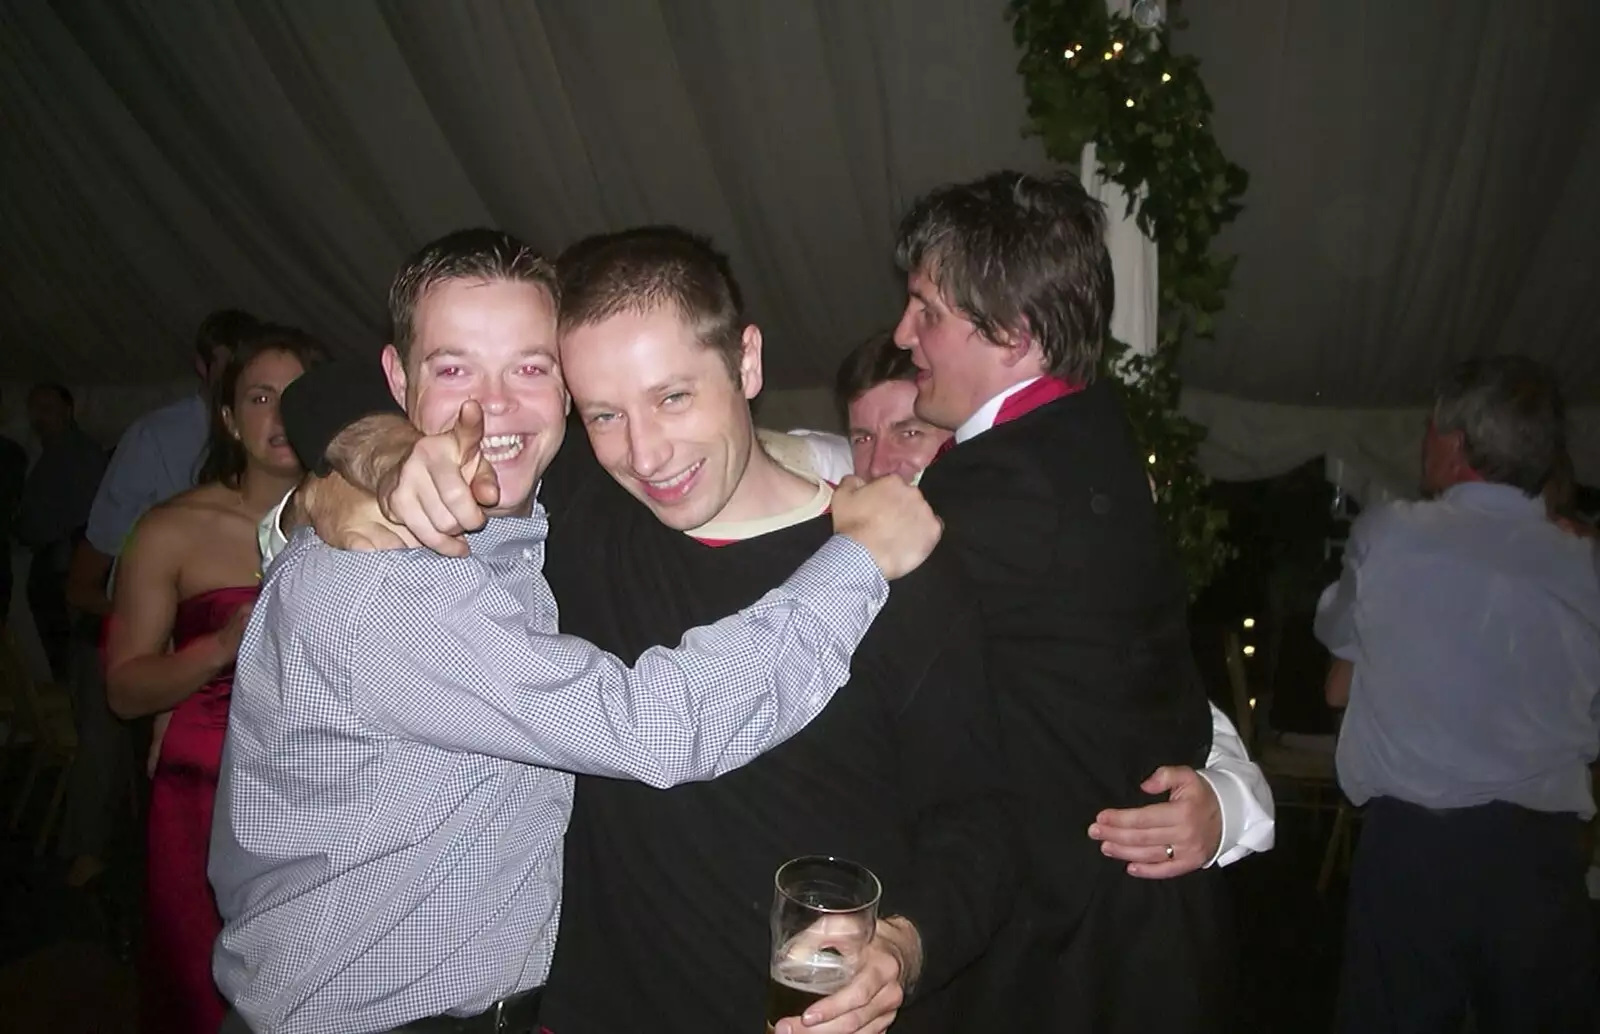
xmin=766 ymin=855 xmax=883 ymax=1034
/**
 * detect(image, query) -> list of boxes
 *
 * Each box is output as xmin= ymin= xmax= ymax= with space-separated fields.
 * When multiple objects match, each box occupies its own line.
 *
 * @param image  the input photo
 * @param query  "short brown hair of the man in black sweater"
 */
xmin=557 ymin=226 xmax=746 ymax=384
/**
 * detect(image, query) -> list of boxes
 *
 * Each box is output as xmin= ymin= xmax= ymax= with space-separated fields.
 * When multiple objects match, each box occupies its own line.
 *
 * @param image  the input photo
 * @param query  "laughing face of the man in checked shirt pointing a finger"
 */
xmin=384 ymin=279 xmax=566 ymax=517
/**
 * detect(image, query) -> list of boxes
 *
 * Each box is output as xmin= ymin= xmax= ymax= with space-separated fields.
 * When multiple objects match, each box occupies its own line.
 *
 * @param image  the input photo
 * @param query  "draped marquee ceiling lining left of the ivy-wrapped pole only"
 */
xmin=0 ymin=0 xmax=1043 ymax=396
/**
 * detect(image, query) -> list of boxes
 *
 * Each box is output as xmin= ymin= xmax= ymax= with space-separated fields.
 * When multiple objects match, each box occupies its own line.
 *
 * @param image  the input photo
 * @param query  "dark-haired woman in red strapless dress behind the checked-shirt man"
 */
xmin=106 ymin=332 xmax=322 ymax=1034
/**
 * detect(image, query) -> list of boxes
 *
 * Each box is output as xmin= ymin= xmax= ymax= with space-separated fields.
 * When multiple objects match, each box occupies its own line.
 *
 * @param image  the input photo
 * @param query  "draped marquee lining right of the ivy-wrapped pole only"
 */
xmin=1178 ymin=0 xmax=1600 ymax=493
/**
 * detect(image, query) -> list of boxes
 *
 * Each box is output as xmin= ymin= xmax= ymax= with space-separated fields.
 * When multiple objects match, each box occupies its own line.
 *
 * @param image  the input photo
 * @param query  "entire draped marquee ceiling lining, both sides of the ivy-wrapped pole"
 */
xmin=0 ymin=0 xmax=1600 ymax=492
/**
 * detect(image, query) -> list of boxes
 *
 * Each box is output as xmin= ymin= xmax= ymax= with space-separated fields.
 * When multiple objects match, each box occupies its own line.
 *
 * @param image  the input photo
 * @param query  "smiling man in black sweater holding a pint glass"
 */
xmin=297 ymin=229 xmax=1014 ymax=1034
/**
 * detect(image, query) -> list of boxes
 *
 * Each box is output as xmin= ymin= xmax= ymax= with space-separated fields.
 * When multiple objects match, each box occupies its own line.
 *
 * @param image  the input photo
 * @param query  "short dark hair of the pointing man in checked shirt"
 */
xmin=389 ymin=227 xmax=562 ymax=362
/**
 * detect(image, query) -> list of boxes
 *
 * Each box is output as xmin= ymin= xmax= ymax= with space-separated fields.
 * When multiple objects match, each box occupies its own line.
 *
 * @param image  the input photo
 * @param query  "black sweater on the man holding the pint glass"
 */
xmin=541 ymin=438 xmax=1013 ymax=1034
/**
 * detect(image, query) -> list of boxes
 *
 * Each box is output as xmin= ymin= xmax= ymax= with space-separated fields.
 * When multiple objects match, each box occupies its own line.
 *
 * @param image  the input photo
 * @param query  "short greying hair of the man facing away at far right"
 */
xmin=1432 ymin=355 xmax=1566 ymax=496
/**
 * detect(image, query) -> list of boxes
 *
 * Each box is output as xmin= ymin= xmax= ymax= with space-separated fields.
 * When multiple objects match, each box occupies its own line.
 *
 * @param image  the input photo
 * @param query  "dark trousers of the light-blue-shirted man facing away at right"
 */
xmin=1334 ymin=797 xmax=1600 ymax=1034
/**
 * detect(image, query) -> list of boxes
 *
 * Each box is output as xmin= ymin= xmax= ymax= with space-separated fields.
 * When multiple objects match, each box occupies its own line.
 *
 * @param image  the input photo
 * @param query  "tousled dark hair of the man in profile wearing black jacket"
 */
xmin=894 ymin=171 xmax=1115 ymax=384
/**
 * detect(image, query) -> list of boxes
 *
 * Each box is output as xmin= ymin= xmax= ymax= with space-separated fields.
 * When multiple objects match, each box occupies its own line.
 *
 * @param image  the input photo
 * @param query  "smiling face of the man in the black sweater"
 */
xmin=562 ymin=307 xmax=762 ymax=531
